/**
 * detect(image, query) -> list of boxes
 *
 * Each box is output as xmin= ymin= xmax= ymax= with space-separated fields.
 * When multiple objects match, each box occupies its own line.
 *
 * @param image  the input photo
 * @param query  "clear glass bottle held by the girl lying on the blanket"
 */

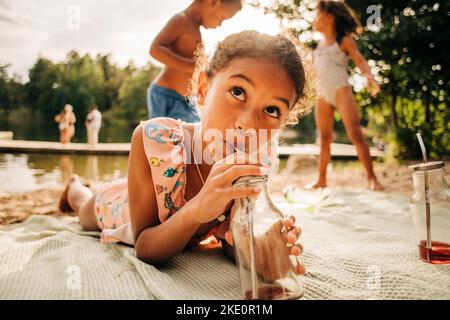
xmin=231 ymin=176 xmax=303 ymax=300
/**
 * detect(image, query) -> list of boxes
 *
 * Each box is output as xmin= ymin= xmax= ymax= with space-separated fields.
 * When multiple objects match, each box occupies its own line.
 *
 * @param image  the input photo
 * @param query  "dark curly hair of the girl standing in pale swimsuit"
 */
xmin=317 ymin=0 xmax=362 ymax=44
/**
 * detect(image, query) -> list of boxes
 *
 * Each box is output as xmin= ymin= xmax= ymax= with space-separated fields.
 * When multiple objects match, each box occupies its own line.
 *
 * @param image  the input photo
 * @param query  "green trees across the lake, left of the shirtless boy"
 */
xmin=0 ymin=51 xmax=159 ymax=126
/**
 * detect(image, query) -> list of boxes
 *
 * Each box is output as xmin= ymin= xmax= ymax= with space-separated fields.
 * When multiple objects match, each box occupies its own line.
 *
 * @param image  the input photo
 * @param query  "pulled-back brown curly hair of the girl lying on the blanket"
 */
xmin=190 ymin=30 xmax=312 ymax=125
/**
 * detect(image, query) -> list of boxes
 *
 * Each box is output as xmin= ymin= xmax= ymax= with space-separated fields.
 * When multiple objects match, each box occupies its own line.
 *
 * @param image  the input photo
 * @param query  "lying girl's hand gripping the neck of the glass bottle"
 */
xmin=190 ymin=152 xmax=268 ymax=224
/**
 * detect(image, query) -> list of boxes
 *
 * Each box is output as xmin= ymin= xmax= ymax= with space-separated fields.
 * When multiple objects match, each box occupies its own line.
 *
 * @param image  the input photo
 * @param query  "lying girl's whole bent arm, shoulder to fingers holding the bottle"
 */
xmin=128 ymin=125 xmax=267 ymax=265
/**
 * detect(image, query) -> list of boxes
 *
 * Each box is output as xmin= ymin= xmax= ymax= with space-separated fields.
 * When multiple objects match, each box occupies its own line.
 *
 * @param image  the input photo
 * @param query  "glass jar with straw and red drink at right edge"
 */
xmin=409 ymin=161 xmax=450 ymax=264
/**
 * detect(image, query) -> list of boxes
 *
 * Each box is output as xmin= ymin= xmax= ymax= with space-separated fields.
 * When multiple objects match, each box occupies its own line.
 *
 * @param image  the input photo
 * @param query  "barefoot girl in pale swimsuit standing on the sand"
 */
xmin=306 ymin=1 xmax=383 ymax=191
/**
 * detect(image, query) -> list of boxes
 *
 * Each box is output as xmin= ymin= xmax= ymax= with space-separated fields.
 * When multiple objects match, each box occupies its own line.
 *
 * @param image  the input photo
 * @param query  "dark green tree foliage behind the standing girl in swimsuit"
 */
xmin=253 ymin=0 xmax=450 ymax=158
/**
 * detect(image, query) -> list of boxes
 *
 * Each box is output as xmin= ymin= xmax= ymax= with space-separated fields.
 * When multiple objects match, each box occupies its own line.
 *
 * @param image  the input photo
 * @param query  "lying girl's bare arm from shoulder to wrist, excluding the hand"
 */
xmin=128 ymin=126 xmax=200 ymax=265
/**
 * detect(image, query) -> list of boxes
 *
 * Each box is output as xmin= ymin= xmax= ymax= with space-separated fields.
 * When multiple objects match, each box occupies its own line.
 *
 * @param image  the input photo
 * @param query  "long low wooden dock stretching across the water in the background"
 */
xmin=0 ymin=140 xmax=385 ymax=158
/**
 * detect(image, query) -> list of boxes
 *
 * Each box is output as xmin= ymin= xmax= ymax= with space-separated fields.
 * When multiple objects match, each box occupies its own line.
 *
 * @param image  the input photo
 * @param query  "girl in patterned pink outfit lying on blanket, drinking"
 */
xmin=60 ymin=31 xmax=308 ymax=280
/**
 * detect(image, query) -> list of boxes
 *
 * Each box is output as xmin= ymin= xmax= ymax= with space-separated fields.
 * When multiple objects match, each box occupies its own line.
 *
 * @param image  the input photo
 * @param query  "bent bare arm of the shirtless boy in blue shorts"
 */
xmin=150 ymin=14 xmax=195 ymax=72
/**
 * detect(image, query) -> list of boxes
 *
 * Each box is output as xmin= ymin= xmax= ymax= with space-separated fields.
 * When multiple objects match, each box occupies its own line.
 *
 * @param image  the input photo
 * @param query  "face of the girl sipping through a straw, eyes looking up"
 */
xmin=198 ymin=57 xmax=296 ymax=161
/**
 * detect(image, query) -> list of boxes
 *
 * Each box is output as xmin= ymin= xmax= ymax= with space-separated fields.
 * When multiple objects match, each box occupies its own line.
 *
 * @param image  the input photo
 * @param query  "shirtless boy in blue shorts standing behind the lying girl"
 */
xmin=147 ymin=0 xmax=242 ymax=122
